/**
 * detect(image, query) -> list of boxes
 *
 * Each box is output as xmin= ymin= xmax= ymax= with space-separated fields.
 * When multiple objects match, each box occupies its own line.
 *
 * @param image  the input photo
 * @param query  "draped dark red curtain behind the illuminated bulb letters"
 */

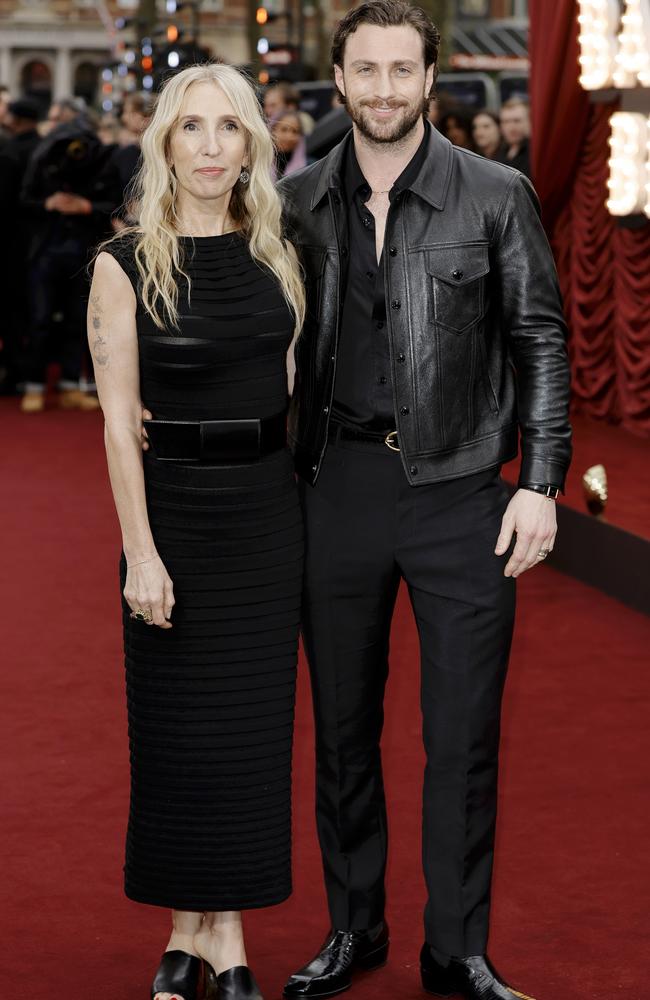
xmin=530 ymin=0 xmax=650 ymax=435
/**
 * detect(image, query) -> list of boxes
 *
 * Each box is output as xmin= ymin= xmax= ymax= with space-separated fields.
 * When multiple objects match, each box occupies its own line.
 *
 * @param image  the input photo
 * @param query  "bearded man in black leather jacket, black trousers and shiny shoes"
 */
xmin=280 ymin=0 xmax=571 ymax=1000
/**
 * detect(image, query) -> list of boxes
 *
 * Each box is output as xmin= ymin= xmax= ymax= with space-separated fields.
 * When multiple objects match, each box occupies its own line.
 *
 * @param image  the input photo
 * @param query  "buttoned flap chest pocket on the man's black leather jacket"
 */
xmin=426 ymin=245 xmax=490 ymax=333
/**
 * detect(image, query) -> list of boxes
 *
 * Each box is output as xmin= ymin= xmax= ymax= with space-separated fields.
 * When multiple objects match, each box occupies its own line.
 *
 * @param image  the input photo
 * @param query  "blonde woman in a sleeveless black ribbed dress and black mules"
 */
xmin=88 ymin=64 xmax=304 ymax=1000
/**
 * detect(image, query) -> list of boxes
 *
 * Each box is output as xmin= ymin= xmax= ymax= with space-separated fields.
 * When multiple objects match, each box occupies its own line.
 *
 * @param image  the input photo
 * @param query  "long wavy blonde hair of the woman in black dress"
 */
xmin=105 ymin=63 xmax=305 ymax=331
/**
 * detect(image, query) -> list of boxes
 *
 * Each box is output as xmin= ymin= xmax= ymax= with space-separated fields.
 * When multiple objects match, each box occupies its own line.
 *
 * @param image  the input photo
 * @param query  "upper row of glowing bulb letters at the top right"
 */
xmin=578 ymin=0 xmax=650 ymax=90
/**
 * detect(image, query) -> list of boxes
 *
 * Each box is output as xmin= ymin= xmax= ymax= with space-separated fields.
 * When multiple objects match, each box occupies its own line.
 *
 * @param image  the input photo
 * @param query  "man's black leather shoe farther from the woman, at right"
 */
xmin=420 ymin=944 xmax=534 ymax=1000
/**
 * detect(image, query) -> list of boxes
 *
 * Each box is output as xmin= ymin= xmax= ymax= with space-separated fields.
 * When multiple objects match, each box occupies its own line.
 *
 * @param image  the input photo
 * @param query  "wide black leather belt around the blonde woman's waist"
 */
xmin=144 ymin=413 xmax=287 ymax=463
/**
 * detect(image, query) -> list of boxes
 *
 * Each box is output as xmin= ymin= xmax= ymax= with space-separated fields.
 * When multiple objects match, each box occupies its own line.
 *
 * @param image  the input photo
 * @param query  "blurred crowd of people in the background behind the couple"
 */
xmin=0 ymin=75 xmax=530 ymax=413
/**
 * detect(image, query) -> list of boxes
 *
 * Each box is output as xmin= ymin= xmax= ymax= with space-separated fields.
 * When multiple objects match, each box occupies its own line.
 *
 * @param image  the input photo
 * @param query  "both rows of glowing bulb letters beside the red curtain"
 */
xmin=578 ymin=0 xmax=650 ymax=218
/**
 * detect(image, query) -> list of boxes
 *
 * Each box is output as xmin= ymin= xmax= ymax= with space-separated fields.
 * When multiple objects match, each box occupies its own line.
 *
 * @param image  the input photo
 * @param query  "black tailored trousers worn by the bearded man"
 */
xmin=301 ymin=442 xmax=515 ymax=957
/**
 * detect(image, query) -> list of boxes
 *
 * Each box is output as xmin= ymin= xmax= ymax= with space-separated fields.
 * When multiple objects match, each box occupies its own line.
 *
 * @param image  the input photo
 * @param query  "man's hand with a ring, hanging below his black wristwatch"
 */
xmin=494 ymin=490 xmax=557 ymax=577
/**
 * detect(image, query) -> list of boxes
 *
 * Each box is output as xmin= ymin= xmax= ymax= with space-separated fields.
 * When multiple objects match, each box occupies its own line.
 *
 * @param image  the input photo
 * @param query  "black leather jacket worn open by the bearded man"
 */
xmin=279 ymin=128 xmax=571 ymax=487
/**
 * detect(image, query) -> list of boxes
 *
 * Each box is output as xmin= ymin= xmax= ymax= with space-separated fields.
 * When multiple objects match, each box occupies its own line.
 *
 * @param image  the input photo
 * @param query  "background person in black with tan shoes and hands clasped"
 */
xmin=21 ymin=102 xmax=122 ymax=413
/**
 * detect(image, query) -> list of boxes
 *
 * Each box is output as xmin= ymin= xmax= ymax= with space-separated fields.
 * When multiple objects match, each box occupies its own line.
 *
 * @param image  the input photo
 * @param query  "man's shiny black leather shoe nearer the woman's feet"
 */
xmin=283 ymin=923 xmax=388 ymax=1000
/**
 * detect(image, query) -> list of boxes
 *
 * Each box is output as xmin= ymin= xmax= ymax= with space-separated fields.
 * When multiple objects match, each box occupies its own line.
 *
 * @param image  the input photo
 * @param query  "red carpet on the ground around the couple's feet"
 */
xmin=0 ymin=401 xmax=650 ymax=1000
